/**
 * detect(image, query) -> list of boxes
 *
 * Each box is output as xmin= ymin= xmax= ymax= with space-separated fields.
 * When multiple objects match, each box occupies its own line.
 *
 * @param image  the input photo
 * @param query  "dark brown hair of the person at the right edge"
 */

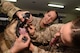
xmin=71 ymin=18 xmax=80 ymax=48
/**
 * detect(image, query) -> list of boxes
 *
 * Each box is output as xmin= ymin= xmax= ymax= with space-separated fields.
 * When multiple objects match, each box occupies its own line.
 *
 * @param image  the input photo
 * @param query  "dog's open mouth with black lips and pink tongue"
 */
xmin=16 ymin=20 xmax=29 ymax=37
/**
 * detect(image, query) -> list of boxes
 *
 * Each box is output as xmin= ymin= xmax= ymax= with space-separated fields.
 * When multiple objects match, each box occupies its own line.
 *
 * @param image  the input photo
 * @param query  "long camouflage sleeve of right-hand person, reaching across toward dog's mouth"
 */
xmin=32 ymin=24 xmax=63 ymax=44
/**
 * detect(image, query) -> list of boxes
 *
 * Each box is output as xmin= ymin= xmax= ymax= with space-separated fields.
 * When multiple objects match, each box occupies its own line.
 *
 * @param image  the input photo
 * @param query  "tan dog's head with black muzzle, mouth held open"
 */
xmin=4 ymin=13 xmax=32 ymax=40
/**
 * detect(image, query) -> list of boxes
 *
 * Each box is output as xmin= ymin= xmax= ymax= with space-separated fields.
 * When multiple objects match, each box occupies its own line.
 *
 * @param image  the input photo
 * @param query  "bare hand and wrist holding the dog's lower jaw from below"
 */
xmin=10 ymin=33 xmax=30 ymax=53
